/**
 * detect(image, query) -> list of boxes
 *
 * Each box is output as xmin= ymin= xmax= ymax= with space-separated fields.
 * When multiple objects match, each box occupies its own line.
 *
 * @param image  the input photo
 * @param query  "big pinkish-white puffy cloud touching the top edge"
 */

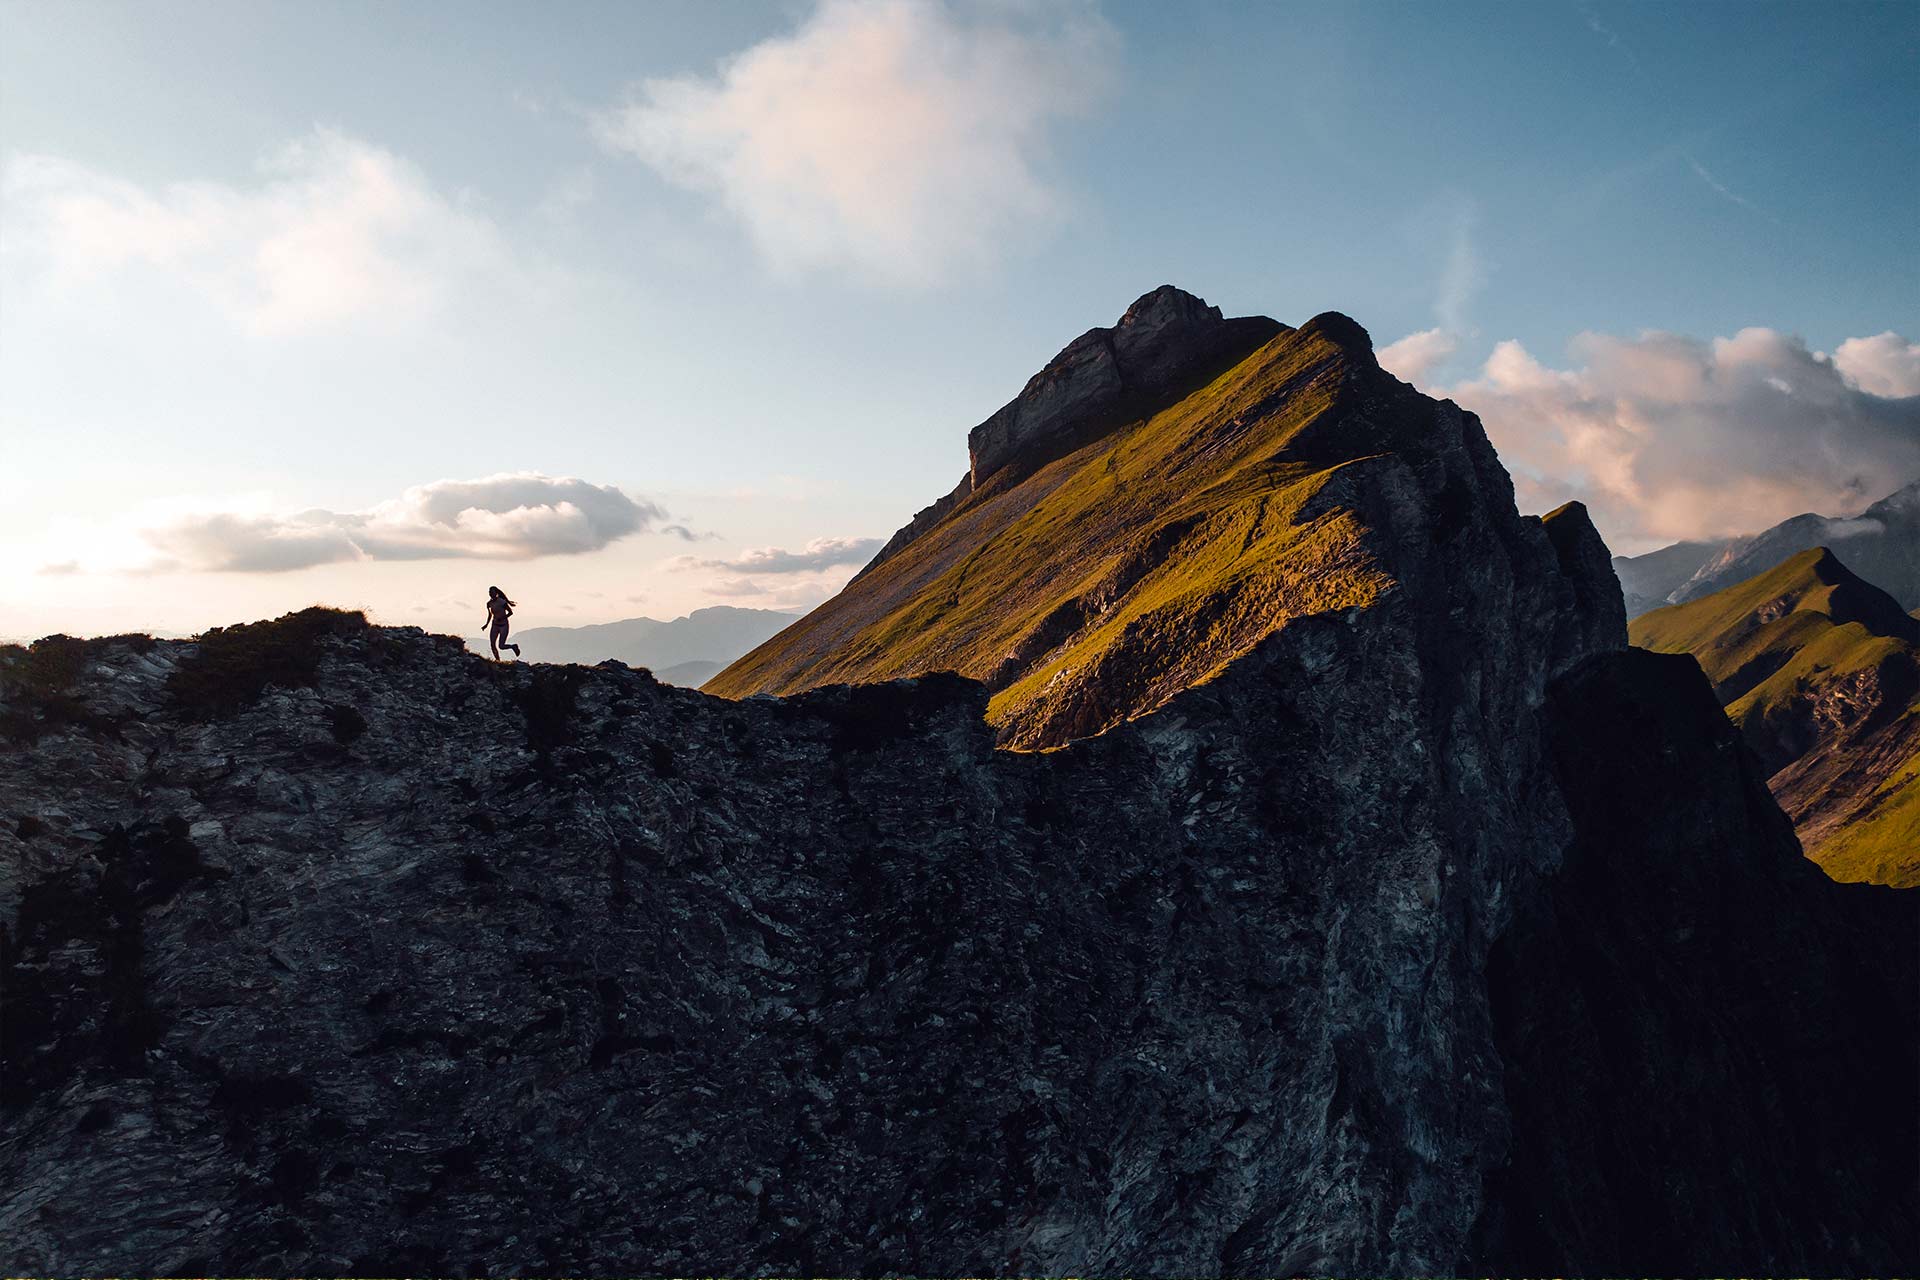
xmin=595 ymin=0 xmax=1117 ymax=286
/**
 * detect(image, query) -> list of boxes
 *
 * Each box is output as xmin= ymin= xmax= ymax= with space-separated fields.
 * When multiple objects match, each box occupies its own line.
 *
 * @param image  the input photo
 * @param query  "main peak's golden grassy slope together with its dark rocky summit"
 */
xmin=705 ymin=288 xmax=1574 ymax=747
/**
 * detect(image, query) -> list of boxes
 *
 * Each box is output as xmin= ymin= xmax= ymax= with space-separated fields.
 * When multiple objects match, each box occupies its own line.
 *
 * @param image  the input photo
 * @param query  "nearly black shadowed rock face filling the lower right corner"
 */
xmin=1469 ymin=649 xmax=1920 ymax=1274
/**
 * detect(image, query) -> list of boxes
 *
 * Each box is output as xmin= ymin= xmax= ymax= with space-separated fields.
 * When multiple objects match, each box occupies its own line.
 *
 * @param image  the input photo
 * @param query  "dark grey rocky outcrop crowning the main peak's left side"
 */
xmin=966 ymin=284 xmax=1286 ymax=489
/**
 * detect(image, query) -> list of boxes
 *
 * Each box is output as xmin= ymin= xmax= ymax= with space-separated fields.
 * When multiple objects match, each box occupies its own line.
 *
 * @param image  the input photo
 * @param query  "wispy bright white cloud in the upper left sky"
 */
xmin=0 ymin=129 xmax=513 ymax=336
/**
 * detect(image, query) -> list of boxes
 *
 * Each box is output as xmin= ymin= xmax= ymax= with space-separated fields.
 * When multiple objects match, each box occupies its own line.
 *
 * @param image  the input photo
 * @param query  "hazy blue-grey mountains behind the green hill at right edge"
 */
xmin=1613 ymin=480 xmax=1920 ymax=618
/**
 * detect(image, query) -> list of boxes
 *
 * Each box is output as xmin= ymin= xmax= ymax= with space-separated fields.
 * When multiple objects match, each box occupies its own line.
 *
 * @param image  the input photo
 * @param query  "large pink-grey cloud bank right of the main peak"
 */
xmin=1443 ymin=328 xmax=1920 ymax=551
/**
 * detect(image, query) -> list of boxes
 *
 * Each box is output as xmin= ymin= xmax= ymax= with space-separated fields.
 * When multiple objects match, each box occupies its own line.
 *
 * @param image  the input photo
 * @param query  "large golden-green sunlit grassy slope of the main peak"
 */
xmin=705 ymin=314 xmax=1388 ymax=747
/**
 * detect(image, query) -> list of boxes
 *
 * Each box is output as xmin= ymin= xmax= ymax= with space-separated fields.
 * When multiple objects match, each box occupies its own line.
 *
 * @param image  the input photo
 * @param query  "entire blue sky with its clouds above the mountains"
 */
xmin=0 ymin=0 xmax=1920 ymax=633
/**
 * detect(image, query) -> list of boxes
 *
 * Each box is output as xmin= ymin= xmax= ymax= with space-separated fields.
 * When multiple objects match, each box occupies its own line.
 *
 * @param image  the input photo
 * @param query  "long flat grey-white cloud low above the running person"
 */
xmin=46 ymin=472 xmax=664 ymax=574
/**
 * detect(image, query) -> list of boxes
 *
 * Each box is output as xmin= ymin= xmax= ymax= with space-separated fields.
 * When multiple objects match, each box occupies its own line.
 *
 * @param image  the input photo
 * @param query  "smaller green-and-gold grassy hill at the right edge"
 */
xmin=1628 ymin=547 xmax=1920 ymax=887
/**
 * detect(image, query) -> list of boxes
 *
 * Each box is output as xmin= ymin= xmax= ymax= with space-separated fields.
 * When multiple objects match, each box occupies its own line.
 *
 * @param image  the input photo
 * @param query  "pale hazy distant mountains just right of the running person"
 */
xmin=513 ymin=604 xmax=795 ymax=687
